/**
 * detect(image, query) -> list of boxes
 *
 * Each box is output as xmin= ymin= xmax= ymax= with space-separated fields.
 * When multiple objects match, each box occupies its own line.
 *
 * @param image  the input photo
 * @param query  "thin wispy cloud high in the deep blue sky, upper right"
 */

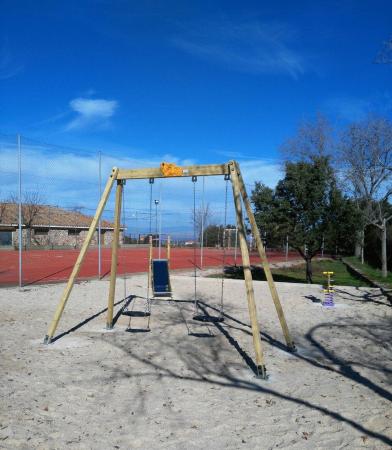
xmin=173 ymin=20 xmax=307 ymax=78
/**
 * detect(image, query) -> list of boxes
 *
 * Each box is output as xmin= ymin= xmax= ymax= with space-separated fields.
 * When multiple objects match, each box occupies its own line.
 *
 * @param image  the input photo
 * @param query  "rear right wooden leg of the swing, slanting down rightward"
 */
xmin=234 ymin=163 xmax=296 ymax=351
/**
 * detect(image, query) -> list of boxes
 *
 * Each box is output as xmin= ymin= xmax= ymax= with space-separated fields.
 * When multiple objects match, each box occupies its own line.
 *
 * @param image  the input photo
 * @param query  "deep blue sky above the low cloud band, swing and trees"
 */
xmin=0 ymin=0 xmax=392 ymax=236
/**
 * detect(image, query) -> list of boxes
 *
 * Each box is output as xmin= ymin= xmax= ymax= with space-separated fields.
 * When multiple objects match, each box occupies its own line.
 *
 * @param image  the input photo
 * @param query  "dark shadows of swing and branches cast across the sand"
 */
xmin=52 ymin=296 xmax=392 ymax=445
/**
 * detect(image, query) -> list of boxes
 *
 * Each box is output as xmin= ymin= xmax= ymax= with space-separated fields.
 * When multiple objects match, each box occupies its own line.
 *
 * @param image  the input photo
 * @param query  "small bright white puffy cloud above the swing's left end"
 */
xmin=66 ymin=97 xmax=118 ymax=130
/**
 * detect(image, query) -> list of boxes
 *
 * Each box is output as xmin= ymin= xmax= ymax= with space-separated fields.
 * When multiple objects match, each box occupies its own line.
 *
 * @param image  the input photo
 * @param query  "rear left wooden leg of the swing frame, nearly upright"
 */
xmin=106 ymin=180 xmax=126 ymax=330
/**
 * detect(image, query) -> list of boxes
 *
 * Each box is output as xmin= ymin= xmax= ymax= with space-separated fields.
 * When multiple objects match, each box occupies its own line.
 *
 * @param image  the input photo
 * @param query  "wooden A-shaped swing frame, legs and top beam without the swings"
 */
xmin=44 ymin=161 xmax=295 ymax=378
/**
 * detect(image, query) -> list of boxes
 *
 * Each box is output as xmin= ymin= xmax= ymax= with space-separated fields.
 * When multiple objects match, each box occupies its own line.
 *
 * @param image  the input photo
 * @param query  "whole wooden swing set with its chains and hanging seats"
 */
xmin=44 ymin=161 xmax=296 ymax=379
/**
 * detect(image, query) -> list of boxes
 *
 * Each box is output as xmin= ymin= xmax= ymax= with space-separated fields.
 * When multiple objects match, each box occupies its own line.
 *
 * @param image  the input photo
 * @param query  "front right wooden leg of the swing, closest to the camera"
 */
xmin=229 ymin=161 xmax=267 ymax=379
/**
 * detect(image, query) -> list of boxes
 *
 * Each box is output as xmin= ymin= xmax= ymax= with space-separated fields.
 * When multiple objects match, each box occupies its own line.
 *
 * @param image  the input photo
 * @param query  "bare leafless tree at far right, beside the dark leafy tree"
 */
xmin=339 ymin=116 xmax=392 ymax=276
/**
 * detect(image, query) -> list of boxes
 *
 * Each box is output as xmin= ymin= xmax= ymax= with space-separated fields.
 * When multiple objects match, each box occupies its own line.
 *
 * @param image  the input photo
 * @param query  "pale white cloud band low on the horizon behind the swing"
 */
xmin=0 ymin=141 xmax=282 ymax=237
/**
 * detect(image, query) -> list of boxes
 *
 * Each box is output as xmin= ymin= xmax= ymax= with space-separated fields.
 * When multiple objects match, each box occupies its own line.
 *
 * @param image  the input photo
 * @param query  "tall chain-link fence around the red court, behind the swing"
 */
xmin=0 ymin=134 xmax=254 ymax=286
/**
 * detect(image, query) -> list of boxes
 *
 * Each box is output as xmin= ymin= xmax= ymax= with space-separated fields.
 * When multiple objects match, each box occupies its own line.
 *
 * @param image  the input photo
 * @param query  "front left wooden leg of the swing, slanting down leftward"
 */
xmin=44 ymin=167 xmax=118 ymax=344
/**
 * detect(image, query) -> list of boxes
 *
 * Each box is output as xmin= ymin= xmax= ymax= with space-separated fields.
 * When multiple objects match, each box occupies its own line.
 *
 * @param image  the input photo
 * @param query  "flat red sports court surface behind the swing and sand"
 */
xmin=0 ymin=247 xmax=298 ymax=286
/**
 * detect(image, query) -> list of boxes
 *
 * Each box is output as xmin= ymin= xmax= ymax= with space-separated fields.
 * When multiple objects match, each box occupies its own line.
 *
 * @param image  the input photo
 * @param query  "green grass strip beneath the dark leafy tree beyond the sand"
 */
xmin=219 ymin=260 xmax=369 ymax=287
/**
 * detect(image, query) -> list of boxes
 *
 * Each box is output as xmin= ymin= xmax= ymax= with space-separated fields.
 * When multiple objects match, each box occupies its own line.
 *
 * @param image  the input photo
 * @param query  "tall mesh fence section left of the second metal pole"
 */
xmin=0 ymin=135 xmax=109 ymax=285
